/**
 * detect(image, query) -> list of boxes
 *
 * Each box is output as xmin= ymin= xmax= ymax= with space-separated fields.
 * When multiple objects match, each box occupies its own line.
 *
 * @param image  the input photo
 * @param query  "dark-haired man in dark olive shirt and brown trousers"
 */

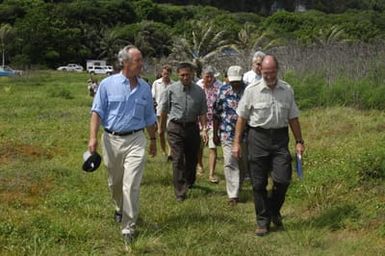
xmin=159 ymin=63 xmax=207 ymax=201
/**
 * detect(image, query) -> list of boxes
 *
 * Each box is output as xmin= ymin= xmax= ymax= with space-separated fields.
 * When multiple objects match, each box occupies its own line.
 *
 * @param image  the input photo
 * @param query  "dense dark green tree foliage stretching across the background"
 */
xmin=0 ymin=0 xmax=385 ymax=68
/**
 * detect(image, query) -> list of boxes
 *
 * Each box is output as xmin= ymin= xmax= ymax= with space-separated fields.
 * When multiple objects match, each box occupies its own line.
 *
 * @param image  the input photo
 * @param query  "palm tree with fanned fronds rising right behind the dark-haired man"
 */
xmin=171 ymin=21 xmax=234 ymax=77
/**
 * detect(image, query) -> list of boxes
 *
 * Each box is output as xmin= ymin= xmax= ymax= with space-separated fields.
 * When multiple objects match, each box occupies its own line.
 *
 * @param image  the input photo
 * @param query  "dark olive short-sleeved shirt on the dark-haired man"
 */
xmin=161 ymin=81 xmax=207 ymax=122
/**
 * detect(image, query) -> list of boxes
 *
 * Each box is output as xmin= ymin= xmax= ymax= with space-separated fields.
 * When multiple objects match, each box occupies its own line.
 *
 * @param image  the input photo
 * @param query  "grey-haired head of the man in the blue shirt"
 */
xmin=118 ymin=45 xmax=143 ymax=76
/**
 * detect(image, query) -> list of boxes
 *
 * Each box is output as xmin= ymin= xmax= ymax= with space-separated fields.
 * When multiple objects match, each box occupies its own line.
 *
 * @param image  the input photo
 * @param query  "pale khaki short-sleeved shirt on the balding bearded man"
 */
xmin=237 ymin=79 xmax=299 ymax=129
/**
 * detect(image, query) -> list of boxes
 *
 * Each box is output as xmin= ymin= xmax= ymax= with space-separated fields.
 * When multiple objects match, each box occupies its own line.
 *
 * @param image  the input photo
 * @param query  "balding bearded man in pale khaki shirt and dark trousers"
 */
xmin=232 ymin=55 xmax=304 ymax=236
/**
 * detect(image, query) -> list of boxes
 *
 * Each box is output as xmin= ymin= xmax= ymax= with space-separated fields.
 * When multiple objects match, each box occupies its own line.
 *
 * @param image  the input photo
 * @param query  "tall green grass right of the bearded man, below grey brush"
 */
xmin=284 ymin=66 xmax=385 ymax=110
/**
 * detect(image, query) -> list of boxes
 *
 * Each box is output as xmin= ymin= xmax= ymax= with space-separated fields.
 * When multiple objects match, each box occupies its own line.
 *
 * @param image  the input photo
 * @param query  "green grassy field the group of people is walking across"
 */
xmin=0 ymin=72 xmax=385 ymax=256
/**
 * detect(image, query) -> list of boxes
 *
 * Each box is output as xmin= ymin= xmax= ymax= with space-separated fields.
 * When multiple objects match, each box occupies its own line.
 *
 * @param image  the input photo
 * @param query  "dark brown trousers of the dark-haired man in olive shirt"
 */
xmin=167 ymin=121 xmax=200 ymax=197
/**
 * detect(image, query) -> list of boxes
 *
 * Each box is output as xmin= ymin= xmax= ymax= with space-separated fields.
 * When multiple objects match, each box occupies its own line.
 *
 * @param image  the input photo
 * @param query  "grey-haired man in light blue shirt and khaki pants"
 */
xmin=88 ymin=45 xmax=156 ymax=243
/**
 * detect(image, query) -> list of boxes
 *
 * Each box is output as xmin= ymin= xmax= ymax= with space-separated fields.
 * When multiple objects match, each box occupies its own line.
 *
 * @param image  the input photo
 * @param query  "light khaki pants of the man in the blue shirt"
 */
xmin=102 ymin=131 xmax=146 ymax=234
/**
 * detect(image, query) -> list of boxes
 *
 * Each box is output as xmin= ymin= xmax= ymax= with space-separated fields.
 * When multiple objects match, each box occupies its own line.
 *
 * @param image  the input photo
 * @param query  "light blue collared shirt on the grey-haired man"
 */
xmin=91 ymin=73 xmax=156 ymax=132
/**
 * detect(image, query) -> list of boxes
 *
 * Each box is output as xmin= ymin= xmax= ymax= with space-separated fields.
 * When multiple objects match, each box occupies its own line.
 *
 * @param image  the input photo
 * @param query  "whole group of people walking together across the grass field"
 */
xmin=88 ymin=45 xmax=304 ymax=243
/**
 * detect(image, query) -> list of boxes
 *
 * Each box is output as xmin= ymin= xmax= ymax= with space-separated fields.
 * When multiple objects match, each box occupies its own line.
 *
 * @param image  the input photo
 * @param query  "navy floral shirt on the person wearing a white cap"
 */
xmin=214 ymin=84 xmax=245 ymax=142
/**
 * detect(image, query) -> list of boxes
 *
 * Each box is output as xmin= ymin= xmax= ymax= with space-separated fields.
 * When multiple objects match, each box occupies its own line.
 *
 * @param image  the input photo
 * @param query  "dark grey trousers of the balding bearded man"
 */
xmin=248 ymin=127 xmax=292 ymax=227
